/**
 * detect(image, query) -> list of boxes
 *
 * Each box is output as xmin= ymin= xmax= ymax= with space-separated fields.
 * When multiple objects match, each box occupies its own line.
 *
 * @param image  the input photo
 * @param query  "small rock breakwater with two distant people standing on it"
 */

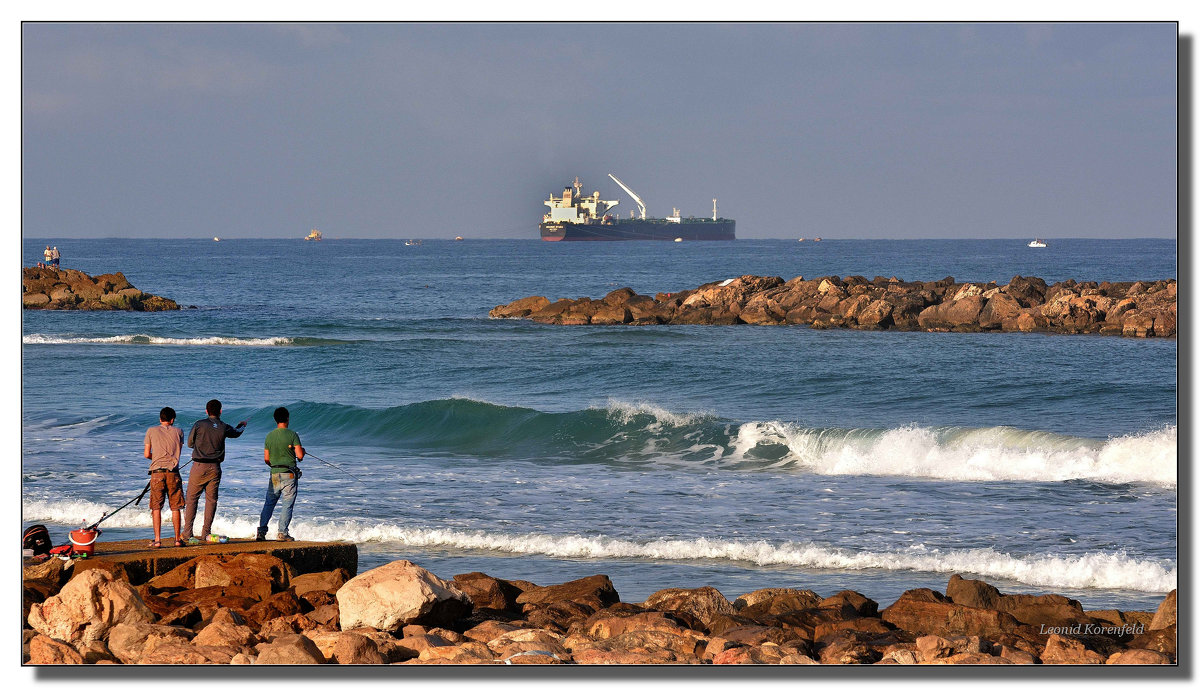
xmin=22 ymin=268 xmax=179 ymax=311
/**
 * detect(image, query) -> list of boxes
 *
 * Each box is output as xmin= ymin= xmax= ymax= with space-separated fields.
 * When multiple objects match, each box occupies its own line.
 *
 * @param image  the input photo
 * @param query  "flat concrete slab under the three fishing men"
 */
xmin=46 ymin=537 xmax=359 ymax=585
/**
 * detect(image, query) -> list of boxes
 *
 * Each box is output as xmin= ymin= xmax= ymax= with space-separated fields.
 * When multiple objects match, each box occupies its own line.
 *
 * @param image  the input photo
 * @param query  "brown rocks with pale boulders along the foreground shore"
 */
xmin=24 ymin=554 xmax=1176 ymax=665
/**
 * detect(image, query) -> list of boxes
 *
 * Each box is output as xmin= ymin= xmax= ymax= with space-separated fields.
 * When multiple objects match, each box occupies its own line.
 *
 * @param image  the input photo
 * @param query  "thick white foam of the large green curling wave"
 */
xmin=722 ymin=421 xmax=1178 ymax=487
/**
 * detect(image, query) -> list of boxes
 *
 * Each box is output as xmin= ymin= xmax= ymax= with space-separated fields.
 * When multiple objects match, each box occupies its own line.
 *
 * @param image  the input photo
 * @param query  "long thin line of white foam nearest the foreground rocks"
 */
xmin=23 ymin=499 xmax=1178 ymax=593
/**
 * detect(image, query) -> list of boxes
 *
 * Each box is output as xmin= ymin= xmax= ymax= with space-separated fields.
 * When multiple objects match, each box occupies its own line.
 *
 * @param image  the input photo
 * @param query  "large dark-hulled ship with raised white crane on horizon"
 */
xmin=539 ymin=174 xmax=737 ymax=241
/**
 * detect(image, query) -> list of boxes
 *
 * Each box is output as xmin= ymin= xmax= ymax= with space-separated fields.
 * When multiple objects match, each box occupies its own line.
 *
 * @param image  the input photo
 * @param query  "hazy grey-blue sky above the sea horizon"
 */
xmin=22 ymin=24 xmax=1177 ymax=239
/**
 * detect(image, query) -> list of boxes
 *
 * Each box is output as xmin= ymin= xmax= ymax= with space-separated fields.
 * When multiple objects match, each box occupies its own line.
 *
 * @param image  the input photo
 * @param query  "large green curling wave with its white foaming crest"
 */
xmin=26 ymin=399 xmax=1178 ymax=489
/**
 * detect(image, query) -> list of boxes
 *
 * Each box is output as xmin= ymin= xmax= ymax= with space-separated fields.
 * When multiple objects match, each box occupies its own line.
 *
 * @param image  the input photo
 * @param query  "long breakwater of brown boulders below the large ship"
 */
xmin=488 ymin=275 xmax=1177 ymax=337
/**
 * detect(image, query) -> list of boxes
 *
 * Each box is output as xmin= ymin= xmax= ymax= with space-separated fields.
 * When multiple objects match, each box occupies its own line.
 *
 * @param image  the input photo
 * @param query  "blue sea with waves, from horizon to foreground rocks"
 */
xmin=20 ymin=237 xmax=1178 ymax=610
